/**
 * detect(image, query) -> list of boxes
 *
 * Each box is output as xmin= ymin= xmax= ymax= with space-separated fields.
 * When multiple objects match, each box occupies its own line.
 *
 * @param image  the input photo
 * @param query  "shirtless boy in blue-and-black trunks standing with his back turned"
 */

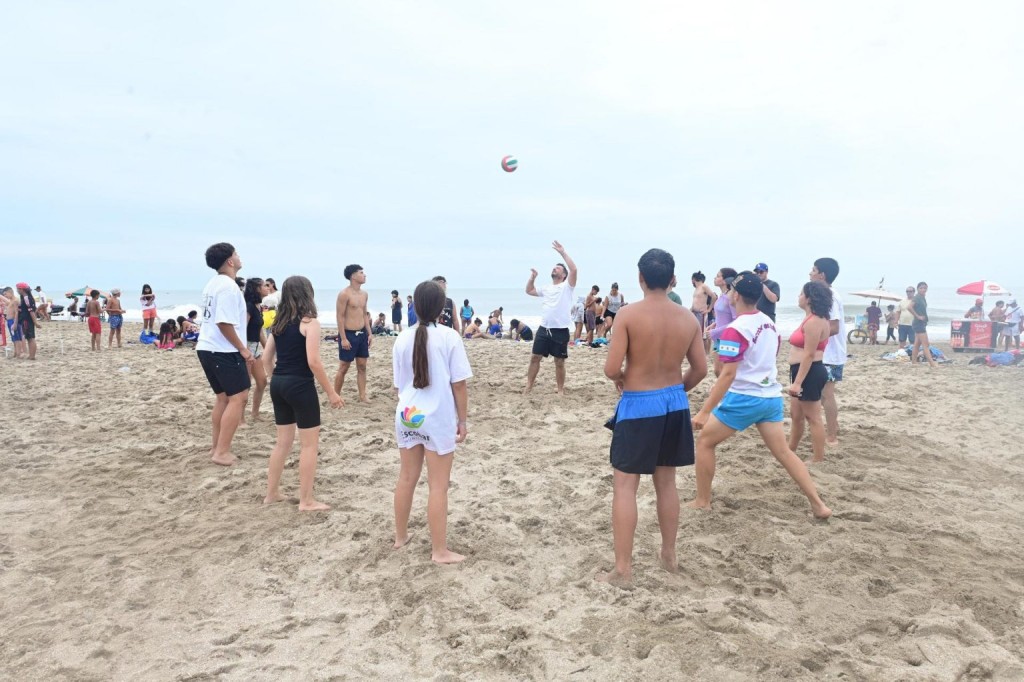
xmin=598 ymin=249 xmax=708 ymax=585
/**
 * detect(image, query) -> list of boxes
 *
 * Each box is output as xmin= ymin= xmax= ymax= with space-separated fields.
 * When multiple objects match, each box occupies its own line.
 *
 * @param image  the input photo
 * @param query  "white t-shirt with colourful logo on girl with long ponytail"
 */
xmin=391 ymin=323 xmax=473 ymax=455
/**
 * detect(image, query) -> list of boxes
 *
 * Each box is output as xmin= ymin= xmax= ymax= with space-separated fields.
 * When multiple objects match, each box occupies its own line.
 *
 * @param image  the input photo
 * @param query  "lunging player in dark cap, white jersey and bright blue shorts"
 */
xmin=689 ymin=270 xmax=831 ymax=518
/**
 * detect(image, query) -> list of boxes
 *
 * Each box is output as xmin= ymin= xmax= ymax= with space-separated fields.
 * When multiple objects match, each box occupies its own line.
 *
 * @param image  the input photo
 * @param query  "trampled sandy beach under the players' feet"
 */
xmin=0 ymin=323 xmax=1024 ymax=680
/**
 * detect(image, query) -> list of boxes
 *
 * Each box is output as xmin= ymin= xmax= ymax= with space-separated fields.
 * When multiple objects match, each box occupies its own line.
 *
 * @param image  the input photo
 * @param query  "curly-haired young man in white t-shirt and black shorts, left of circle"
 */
xmin=196 ymin=242 xmax=256 ymax=467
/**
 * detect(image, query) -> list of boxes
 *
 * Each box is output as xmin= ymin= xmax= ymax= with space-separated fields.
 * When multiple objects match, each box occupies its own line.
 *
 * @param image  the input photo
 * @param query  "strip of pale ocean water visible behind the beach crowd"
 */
xmin=46 ymin=285 xmax=995 ymax=340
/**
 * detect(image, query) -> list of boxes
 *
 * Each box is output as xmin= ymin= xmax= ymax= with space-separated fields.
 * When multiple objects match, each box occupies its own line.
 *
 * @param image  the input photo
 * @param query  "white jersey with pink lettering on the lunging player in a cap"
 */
xmin=718 ymin=310 xmax=782 ymax=397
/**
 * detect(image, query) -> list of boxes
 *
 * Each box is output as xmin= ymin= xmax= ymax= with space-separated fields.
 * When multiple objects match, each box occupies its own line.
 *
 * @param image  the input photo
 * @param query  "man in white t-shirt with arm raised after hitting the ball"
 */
xmin=524 ymin=241 xmax=577 ymax=395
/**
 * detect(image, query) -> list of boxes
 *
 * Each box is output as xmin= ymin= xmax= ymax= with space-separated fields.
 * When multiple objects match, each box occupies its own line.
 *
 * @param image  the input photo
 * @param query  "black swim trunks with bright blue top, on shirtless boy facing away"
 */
xmin=605 ymin=385 xmax=693 ymax=474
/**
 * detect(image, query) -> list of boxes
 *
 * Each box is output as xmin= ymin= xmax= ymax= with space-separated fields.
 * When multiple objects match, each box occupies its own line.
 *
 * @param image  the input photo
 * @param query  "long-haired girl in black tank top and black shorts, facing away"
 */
xmin=261 ymin=274 xmax=345 ymax=511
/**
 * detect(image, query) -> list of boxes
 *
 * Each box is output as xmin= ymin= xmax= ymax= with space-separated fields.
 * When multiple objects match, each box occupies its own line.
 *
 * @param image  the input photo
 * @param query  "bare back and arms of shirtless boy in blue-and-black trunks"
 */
xmin=608 ymin=290 xmax=708 ymax=391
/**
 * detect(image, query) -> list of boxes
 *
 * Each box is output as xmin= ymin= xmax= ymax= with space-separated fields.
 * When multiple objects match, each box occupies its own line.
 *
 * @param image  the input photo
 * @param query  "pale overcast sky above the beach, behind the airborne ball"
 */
xmin=0 ymin=0 xmax=1024 ymax=291
